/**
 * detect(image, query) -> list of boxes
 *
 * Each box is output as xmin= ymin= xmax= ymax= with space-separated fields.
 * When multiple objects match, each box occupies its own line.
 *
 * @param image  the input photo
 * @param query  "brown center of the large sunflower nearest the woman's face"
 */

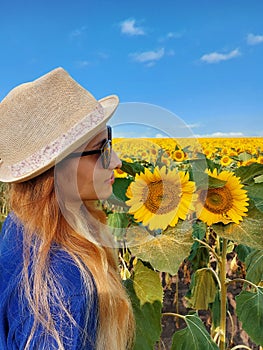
xmin=142 ymin=181 xmax=181 ymax=214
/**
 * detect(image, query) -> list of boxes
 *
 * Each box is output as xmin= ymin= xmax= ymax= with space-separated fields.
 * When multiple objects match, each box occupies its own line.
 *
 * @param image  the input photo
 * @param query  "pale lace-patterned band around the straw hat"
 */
xmin=8 ymin=104 xmax=104 ymax=178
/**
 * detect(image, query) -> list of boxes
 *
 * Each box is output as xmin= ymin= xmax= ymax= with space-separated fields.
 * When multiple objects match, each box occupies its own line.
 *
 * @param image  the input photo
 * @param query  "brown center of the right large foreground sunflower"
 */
xmin=204 ymin=187 xmax=233 ymax=214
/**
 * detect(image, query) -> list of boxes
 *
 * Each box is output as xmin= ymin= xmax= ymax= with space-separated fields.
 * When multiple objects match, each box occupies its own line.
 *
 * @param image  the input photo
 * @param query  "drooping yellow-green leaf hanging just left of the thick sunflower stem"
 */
xmin=188 ymin=268 xmax=217 ymax=310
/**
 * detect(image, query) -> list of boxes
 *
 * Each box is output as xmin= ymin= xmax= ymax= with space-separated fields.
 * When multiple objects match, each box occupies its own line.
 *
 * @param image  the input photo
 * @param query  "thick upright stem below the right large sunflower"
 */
xmin=219 ymin=238 xmax=227 ymax=350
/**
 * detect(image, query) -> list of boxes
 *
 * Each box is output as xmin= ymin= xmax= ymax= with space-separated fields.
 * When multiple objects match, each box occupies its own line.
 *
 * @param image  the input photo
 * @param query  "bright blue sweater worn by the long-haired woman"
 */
xmin=0 ymin=213 xmax=98 ymax=350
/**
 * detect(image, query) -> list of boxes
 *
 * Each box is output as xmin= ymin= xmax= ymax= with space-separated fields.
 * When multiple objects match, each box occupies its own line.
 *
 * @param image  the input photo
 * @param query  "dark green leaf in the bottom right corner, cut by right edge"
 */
xmin=236 ymin=287 xmax=263 ymax=346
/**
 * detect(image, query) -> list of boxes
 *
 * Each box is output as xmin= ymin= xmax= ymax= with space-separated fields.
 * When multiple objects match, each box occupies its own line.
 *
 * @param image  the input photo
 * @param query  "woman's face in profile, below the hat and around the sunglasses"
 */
xmin=58 ymin=128 xmax=121 ymax=202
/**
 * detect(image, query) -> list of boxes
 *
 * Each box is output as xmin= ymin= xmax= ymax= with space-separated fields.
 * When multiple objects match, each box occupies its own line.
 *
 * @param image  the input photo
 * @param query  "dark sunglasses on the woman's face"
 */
xmin=67 ymin=126 xmax=112 ymax=169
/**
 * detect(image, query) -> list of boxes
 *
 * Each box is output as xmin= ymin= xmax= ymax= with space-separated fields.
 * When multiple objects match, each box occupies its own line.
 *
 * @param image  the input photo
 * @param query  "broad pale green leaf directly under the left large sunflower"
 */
xmin=127 ymin=224 xmax=193 ymax=275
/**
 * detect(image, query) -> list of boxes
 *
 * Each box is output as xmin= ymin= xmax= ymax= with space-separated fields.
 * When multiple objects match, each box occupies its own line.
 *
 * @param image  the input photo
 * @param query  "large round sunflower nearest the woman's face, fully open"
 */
xmin=126 ymin=166 xmax=195 ymax=230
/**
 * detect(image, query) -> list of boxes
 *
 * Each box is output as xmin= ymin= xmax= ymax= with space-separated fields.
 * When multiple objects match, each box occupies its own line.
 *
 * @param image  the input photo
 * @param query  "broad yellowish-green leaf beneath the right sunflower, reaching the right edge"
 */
xmin=213 ymin=207 xmax=263 ymax=249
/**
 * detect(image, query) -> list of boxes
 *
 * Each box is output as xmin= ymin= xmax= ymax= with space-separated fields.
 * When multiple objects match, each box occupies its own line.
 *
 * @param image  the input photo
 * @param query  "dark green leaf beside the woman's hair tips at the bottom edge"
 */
xmin=124 ymin=279 xmax=162 ymax=350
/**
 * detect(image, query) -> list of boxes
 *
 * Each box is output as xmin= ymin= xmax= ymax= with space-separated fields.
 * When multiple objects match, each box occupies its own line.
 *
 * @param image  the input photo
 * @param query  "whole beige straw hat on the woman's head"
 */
xmin=0 ymin=68 xmax=119 ymax=182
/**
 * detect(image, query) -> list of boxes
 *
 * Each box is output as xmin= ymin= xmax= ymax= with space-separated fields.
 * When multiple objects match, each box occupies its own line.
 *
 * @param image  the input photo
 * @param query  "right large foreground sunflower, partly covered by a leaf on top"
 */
xmin=196 ymin=169 xmax=251 ymax=225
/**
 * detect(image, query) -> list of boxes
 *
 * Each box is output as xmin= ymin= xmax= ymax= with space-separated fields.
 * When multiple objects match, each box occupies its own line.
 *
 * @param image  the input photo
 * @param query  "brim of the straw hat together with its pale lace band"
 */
xmin=0 ymin=95 xmax=119 ymax=183
